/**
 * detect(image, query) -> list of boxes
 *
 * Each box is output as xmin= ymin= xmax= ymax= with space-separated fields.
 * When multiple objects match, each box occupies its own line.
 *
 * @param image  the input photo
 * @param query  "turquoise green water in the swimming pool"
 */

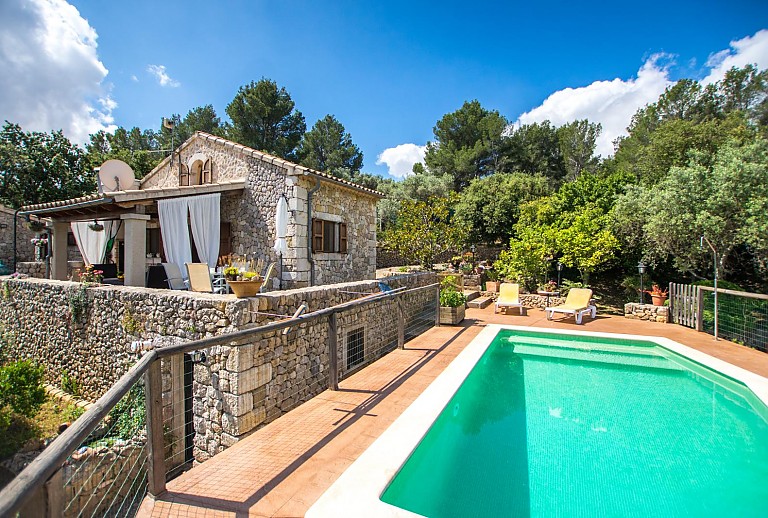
xmin=381 ymin=330 xmax=768 ymax=517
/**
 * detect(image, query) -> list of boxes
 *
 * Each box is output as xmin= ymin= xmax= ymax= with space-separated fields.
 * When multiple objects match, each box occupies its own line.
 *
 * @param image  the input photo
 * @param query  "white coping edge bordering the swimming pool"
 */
xmin=305 ymin=324 xmax=768 ymax=518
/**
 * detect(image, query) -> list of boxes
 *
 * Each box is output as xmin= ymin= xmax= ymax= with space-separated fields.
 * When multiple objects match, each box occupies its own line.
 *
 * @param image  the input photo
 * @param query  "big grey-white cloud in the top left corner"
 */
xmin=0 ymin=0 xmax=117 ymax=144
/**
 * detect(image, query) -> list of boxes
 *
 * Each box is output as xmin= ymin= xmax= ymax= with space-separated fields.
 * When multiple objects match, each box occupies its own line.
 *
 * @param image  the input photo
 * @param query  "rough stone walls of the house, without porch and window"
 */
xmin=141 ymin=133 xmax=379 ymax=289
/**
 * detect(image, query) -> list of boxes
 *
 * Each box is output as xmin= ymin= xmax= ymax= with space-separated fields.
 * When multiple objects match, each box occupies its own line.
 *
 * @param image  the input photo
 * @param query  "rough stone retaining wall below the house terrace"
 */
xmin=0 ymin=273 xmax=435 ymax=465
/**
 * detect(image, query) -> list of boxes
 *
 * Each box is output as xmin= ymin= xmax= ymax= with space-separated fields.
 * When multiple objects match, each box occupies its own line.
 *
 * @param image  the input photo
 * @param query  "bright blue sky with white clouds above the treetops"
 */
xmin=0 ymin=0 xmax=768 ymax=176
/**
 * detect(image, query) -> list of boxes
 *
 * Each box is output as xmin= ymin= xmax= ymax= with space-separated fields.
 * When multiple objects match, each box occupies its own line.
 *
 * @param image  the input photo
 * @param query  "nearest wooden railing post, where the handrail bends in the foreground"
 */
xmin=144 ymin=360 xmax=165 ymax=498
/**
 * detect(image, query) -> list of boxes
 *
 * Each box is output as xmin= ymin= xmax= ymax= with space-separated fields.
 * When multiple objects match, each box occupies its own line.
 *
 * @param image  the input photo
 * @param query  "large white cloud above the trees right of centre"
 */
xmin=515 ymin=54 xmax=673 ymax=157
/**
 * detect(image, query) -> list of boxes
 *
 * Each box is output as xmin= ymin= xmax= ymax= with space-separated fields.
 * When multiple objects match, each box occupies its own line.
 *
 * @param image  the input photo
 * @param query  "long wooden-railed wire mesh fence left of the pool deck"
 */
xmin=0 ymin=284 xmax=439 ymax=517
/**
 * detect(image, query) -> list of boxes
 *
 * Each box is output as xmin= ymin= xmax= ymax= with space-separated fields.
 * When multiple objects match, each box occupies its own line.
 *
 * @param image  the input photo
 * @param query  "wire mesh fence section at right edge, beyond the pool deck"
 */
xmin=702 ymin=290 xmax=768 ymax=352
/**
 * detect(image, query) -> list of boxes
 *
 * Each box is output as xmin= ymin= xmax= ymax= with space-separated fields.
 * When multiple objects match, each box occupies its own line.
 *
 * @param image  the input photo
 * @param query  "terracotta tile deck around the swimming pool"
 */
xmin=139 ymin=306 xmax=768 ymax=517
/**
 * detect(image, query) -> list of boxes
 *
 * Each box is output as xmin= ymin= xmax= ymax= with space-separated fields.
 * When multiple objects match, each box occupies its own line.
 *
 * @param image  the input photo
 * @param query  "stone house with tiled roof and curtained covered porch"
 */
xmin=20 ymin=132 xmax=383 ymax=289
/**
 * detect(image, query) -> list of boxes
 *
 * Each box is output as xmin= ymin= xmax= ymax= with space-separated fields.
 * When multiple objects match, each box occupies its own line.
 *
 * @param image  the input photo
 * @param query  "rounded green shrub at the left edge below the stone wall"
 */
xmin=0 ymin=360 xmax=46 ymax=429
